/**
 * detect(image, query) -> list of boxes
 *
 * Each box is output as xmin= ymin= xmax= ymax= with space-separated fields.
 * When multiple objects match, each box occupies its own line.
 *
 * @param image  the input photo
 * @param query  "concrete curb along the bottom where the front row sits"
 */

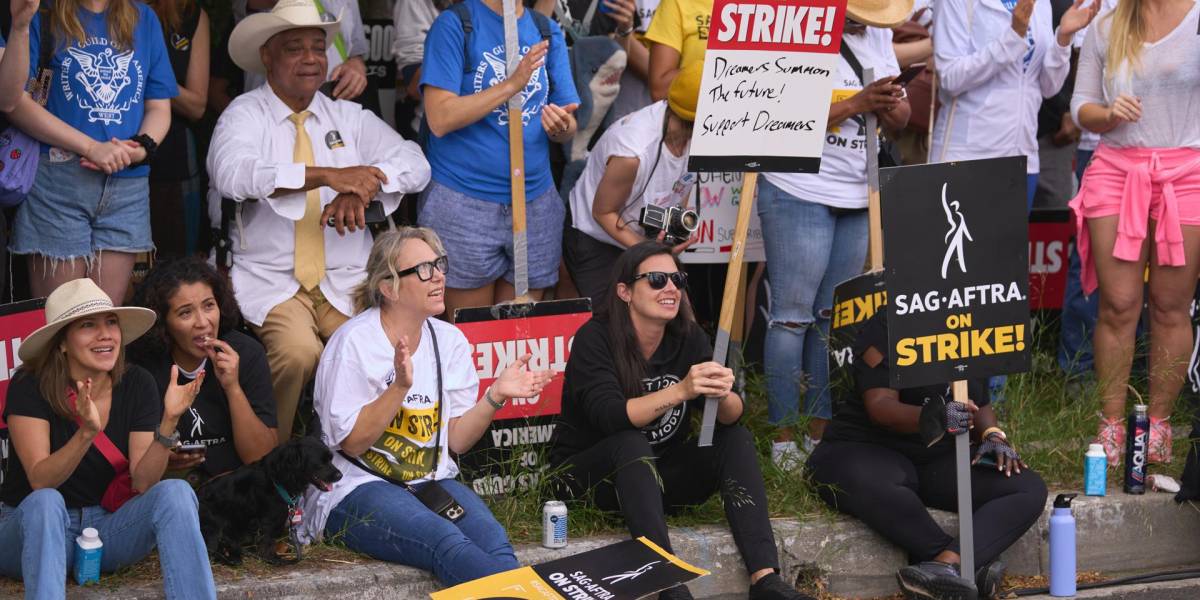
xmin=70 ymin=492 xmax=1200 ymax=600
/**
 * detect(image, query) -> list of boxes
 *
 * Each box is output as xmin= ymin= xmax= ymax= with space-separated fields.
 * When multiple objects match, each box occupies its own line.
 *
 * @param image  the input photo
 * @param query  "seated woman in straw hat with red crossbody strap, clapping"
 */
xmin=0 ymin=278 xmax=216 ymax=599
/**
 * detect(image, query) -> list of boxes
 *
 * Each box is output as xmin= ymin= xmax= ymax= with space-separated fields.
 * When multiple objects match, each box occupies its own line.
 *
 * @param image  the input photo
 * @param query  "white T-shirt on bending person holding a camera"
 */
xmin=570 ymin=100 xmax=688 ymax=248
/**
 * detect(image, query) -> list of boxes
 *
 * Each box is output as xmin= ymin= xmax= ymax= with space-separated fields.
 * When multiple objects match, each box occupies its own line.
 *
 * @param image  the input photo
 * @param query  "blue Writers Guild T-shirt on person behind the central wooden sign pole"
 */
xmin=421 ymin=0 xmax=580 ymax=204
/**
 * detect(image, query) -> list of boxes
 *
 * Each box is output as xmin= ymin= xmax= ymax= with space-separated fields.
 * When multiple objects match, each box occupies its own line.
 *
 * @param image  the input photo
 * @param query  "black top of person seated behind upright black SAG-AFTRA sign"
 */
xmin=823 ymin=311 xmax=990 ymax=456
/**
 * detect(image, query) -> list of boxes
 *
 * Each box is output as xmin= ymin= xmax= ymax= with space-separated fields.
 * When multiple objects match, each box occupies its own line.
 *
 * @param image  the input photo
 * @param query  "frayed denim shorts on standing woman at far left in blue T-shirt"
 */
xmin=8 ymin=154 xmax=153 ymax=259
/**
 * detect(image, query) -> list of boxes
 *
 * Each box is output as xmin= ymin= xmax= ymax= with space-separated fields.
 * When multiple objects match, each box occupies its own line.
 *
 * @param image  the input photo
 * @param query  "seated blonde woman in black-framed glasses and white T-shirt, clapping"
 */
xmin=300 ymin=227 xmax=552 ymax=586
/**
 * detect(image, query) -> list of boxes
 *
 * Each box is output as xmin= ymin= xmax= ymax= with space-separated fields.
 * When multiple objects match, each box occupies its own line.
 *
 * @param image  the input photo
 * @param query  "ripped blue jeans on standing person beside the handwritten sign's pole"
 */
xmin=758 ymin=178 xmax=868 ymax=425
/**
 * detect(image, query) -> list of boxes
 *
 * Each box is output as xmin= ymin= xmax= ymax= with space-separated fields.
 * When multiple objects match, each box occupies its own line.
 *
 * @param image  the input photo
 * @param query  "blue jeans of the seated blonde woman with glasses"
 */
xmin=325 ymin=479 xmax=520 ymax=586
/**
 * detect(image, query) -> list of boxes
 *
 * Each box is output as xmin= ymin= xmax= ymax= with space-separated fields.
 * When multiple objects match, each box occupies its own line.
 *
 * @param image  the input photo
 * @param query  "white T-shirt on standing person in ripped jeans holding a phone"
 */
xmin=763 ymin=28 xmax=900 ymax=209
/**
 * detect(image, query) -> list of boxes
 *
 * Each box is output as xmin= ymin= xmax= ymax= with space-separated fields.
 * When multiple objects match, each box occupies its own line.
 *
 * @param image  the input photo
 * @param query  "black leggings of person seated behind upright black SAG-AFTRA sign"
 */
xmin=809 ymin=440 xmax=1046 ymax=565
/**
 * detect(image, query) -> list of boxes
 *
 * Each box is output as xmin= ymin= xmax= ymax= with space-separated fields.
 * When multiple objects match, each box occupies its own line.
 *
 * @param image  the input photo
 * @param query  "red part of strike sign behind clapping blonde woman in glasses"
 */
xmin=457 ymin=312 xmax=592 ymax=420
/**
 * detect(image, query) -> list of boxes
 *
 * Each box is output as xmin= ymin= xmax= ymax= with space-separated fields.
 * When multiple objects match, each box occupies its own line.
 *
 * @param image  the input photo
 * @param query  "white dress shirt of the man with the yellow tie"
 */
xmin=208 ymin=85 xmax=430 ymax=325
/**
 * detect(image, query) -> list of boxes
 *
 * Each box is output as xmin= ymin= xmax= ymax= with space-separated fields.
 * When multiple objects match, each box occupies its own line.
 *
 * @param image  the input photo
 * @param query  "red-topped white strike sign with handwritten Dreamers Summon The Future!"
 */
xmin=688 ymin=0 xmax=846 ymax=173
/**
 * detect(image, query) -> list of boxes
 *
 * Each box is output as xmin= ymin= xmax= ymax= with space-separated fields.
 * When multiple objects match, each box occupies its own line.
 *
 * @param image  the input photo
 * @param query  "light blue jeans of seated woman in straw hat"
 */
xmin=0 ymin=479 xmax=217 ymax=600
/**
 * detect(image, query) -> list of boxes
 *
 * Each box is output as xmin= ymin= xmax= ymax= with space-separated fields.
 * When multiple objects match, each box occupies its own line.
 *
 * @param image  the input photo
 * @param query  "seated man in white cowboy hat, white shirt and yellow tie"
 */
xmin=208 ymin=0 xmax=430 ymax=443
